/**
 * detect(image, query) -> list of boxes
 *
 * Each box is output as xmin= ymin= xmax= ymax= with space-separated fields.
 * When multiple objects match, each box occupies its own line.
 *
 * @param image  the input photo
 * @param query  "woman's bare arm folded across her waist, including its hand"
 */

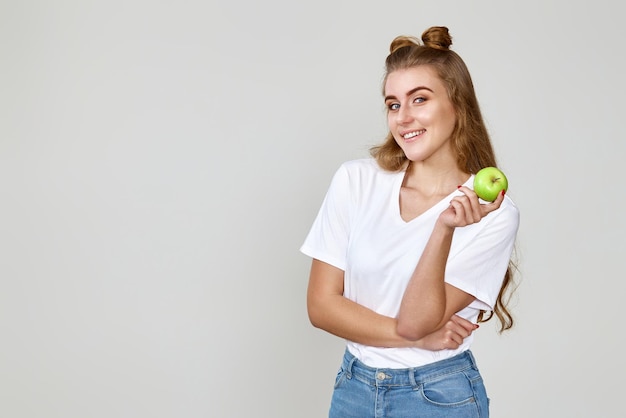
xmin=307 ymin=259 xmax=477 ymax=350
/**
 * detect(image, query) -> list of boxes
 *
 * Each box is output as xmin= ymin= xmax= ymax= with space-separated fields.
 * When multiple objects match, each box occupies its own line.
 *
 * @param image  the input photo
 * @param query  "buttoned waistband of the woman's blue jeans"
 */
xmin=342 ymin=349 xmax=478 ymax=387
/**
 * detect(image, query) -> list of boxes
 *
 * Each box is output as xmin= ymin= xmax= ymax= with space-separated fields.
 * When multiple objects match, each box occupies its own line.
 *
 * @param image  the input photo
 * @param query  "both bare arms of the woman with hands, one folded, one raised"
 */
xmin=307 ymin=187 xmax=504 ymax=350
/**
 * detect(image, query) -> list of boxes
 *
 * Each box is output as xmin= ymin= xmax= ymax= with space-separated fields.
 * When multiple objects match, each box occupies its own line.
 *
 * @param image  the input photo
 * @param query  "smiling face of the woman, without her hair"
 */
xmin=384 ymin=65 xmax=456 ymax=162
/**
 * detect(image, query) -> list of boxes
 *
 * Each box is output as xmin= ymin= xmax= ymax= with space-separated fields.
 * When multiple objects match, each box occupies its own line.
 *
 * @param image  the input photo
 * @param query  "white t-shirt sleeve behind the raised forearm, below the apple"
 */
xmin=446 ymin=204 xmax=519 ymax=310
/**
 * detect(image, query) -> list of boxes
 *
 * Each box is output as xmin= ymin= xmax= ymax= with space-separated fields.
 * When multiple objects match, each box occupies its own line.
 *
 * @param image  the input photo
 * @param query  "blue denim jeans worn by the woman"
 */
xmin=328 ymin=350 xmax=489 ymax=418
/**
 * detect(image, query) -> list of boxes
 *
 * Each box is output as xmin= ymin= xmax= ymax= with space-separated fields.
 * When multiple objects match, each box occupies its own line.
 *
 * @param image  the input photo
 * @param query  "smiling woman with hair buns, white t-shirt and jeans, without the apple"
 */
xmin=301 ymin=27 xmax=519 ymax=418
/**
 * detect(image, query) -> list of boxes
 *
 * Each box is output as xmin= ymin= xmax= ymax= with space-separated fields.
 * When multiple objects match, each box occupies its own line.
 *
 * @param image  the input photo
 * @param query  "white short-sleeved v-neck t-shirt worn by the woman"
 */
xmin=300 ymin=158 xmax=519 ymax=368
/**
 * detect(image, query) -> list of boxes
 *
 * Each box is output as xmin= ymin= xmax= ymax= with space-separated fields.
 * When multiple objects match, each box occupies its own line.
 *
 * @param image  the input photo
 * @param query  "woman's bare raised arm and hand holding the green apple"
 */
xmin=397 ymin=187 xmax=504 ymax=340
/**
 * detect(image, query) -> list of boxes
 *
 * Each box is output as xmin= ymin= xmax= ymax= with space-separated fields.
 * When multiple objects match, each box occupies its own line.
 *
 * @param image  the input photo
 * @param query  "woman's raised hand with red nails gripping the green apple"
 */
xmin=439 ymin=186 xmax=504 ymax=228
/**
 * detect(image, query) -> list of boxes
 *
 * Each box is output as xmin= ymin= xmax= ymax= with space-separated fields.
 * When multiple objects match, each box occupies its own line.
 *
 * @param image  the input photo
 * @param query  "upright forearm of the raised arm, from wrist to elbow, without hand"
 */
xmin=397 ymin=222 xmax=454 ymax=340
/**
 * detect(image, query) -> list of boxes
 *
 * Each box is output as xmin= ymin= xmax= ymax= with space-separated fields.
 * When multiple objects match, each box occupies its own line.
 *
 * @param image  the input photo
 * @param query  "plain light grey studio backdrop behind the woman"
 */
xmin=0 ymin=0 xmax=626 ymax=418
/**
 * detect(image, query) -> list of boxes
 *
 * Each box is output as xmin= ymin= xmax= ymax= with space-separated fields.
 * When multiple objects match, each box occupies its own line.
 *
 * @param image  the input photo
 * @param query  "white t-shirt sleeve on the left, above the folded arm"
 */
xmin=300 ymin=165 xmax=352 ymax=270
